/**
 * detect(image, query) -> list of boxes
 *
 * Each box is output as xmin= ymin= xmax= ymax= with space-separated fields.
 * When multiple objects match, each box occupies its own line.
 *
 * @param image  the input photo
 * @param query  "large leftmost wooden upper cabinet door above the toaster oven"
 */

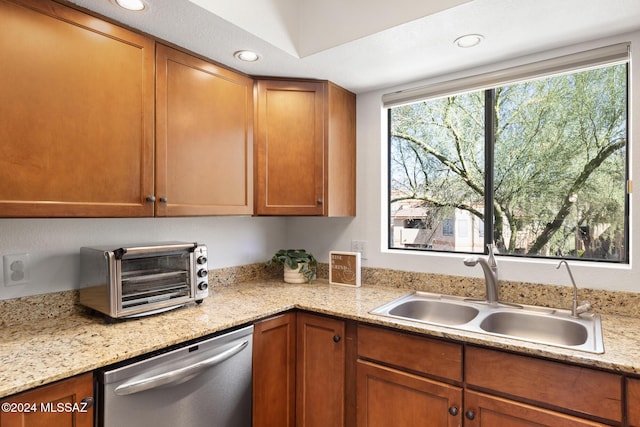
xmin=0 ymin=0 xmax=154 ymax=217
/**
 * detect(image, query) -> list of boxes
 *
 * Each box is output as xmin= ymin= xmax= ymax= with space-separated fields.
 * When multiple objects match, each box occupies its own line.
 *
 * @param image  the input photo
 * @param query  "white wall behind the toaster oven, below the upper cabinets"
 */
xmin=0 ymin=217 xmax=287 ymax=299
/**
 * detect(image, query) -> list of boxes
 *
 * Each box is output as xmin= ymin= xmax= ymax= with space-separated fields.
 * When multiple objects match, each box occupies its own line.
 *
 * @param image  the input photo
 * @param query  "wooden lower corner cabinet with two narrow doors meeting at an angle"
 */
xmin=253 ymin=313 xmax=355 ymax=427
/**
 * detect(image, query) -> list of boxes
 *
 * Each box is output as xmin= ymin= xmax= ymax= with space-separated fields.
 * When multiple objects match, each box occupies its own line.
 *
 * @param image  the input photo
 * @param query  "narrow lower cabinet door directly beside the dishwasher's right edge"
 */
xmin=253 ymin=313 xmax=296 ymax=427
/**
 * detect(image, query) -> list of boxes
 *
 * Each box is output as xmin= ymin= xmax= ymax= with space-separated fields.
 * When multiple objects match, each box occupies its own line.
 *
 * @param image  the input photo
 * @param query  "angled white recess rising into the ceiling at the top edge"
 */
xmin=185 ymin=0 xmax=471 ymax=58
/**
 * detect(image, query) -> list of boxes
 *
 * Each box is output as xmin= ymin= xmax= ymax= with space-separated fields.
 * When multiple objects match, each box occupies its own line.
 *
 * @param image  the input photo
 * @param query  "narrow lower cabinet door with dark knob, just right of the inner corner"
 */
xmin=296 ymin=313 xmax=346 ymax=427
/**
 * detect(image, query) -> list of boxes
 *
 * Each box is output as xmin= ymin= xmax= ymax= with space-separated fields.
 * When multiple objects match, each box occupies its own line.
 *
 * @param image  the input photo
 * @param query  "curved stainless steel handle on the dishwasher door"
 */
xmin=114 ymin=341 xmax=249 ymax=396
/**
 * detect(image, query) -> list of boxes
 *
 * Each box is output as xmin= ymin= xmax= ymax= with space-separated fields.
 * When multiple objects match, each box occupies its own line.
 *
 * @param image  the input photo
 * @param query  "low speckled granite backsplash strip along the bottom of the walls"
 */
xmin=0 ymin=263 xmax=640 ymax=327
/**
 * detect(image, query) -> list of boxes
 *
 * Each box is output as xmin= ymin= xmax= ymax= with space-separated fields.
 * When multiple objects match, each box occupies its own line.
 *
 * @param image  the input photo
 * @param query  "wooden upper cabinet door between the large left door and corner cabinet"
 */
xmin=156 ymin=45 xmax=253 ymax=216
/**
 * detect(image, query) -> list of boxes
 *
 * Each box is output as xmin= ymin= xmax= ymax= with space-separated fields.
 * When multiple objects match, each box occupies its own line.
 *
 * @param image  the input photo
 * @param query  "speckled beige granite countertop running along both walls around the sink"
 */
xmin=0 ymin=280 xmax=640 ymax=397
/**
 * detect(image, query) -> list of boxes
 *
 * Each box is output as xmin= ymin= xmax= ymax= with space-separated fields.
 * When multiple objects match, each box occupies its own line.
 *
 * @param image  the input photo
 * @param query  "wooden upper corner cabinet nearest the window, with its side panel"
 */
xmin=255 ymin=80 xmax=356 ymax=216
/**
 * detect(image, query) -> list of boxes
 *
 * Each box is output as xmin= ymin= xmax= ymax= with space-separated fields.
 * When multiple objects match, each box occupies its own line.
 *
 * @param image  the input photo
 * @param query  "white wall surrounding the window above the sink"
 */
xmin=289 ymin=32 xmax=640 ymax=292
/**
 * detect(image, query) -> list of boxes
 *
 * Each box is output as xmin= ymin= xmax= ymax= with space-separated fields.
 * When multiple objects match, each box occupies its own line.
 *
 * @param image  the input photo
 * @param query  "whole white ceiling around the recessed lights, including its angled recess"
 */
xmin=70 ymin=0 xmax=640 ymax=93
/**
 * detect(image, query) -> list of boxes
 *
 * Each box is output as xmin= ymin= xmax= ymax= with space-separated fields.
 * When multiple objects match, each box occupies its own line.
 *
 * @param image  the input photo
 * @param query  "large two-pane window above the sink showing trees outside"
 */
xmin=388 ymin=45 xmax=629 ymax=262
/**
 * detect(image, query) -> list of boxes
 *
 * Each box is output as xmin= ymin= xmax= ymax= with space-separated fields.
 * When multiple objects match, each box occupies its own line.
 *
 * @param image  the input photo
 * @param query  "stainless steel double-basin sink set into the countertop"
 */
xmin=370 ymin=292 xmax=604 ymax=353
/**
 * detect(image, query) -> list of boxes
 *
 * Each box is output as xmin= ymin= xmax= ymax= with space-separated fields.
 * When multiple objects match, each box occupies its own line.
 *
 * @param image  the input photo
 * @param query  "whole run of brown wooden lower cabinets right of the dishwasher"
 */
xmin=254 ymin=312 xmax=640 ymax=427
